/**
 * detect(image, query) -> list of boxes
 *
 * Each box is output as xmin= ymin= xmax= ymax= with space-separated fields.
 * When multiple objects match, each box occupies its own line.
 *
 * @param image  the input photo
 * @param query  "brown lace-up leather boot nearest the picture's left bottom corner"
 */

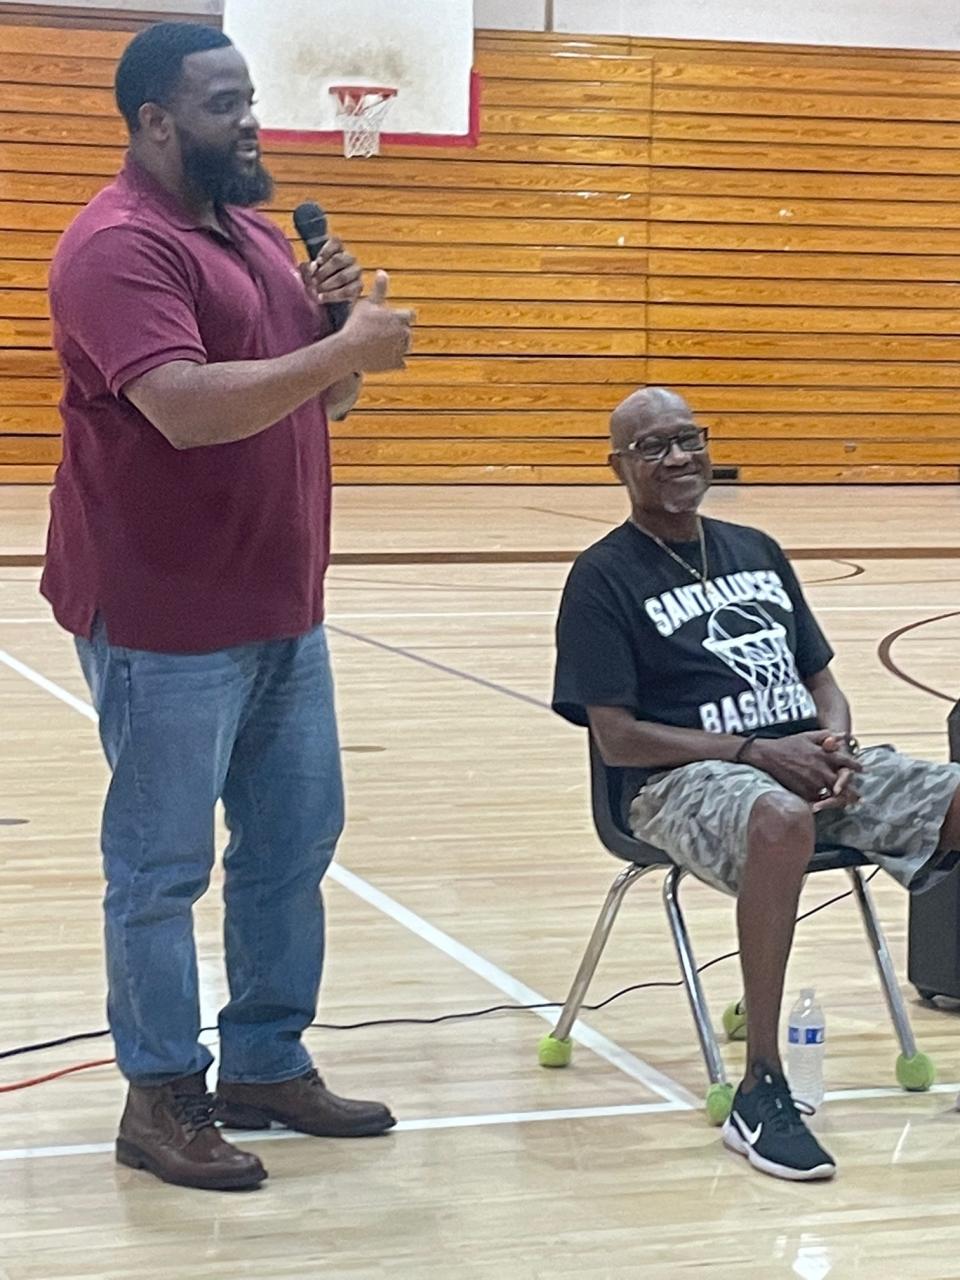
xmin=116 ymin=1074 xmax=266 ymax=1192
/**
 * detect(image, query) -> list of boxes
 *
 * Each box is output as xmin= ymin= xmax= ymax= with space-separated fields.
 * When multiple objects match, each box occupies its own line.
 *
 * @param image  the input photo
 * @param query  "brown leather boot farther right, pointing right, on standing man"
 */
xmin=215 ymin=1071 xmax=397 ymax=1138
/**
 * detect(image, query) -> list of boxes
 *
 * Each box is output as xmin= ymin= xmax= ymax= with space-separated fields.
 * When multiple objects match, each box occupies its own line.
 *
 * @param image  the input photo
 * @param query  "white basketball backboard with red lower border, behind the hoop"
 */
xmin=224 ymin=0 xmax=477 ymax=146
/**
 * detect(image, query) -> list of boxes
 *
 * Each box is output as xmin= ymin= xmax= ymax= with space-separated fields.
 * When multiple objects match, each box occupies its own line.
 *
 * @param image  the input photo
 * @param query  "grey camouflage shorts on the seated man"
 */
xmin=630 ymin=746 xmax=960 ymax=893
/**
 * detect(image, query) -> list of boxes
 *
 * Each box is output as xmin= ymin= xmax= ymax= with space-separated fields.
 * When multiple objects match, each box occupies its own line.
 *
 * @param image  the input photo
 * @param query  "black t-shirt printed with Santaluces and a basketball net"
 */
xmin=553 ymin=520 xmax=833 ymax=812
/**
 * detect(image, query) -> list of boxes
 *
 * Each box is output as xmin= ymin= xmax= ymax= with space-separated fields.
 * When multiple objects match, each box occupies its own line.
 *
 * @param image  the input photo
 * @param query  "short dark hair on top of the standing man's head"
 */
xmin=115 ymin=22 xmax=233 ymax=133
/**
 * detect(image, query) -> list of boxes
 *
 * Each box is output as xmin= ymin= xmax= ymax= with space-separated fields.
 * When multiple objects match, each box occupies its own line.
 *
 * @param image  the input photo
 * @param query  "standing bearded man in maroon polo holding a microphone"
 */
xmin=42 ymin=23 xmax=412 ymax=1189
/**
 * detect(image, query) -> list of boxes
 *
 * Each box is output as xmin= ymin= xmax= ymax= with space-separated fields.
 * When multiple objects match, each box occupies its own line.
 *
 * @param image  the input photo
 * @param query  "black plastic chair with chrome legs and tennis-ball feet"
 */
xmin=539 ymin=737 xmax=934 ymax=1124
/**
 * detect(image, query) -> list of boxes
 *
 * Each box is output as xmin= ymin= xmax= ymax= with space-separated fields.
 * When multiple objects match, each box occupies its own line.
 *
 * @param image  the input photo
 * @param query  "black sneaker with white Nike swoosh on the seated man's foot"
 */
xmin=723 ymin=1062 xmax=837 ymax=1183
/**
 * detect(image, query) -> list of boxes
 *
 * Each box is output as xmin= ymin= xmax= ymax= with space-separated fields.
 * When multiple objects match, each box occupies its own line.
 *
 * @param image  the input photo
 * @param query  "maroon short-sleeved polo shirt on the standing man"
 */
xmin=41 ymin=160 xmax=330 ymax=653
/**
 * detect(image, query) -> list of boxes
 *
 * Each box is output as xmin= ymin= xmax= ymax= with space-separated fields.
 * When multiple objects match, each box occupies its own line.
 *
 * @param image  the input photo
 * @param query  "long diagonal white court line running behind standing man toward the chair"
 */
xmin=0 ymin=649 xmax=700 ymax=1110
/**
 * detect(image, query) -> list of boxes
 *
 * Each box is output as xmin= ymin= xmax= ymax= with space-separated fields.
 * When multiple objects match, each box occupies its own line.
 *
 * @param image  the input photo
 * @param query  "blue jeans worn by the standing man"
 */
xmin=77 ymin=621 xmax=343 ymax=1085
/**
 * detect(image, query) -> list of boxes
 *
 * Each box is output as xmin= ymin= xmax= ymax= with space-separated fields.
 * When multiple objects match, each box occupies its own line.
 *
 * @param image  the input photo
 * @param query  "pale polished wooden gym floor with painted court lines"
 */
xmin=0 ymin=486 xmax=960 ymax=1280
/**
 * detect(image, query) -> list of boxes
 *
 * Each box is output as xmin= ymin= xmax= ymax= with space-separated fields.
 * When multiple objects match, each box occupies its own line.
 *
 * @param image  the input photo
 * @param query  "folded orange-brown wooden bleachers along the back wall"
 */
xmin=0 ymin=18 xmax=960 ymax=484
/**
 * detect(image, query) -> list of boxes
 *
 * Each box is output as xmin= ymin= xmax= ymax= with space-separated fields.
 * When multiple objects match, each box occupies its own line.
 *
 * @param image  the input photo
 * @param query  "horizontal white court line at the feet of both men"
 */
xmin=0 ymin=1084 xmax=960 ymax=1164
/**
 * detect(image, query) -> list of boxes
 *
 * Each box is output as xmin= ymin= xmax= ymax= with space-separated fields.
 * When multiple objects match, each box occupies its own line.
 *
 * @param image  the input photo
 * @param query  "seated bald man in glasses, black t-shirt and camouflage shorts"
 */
xmin=553 ymin=388 xmax=960 ymax=1179
